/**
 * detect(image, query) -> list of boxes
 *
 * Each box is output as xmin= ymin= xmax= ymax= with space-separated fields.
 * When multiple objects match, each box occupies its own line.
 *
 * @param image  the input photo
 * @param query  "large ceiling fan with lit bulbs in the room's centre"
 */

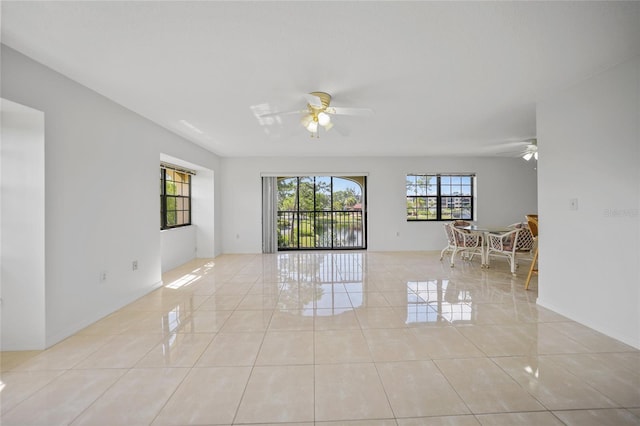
xmin=260 ymin=92 xmax=373 ymax=138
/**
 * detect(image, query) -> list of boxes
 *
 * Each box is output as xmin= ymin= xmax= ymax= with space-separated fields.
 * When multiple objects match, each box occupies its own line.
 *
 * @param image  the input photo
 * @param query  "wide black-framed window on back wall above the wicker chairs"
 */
xmin=406 ymin=174 xmax=475 ymax=221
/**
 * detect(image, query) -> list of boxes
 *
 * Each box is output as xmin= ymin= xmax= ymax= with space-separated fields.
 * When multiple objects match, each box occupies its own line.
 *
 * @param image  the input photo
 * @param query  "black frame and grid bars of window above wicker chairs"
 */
xmin=405 ymin=173 xmax=476 ymax=222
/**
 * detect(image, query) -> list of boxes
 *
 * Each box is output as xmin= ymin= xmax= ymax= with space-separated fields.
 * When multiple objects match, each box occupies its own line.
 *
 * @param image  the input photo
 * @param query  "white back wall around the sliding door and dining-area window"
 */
xmin=222 ymin=158 xmax=537 ymax=253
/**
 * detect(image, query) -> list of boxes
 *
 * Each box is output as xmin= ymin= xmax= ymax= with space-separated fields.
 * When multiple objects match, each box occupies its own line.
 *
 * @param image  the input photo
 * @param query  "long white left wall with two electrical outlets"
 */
xmin=2 ymin=45 xmax=222 ymax=346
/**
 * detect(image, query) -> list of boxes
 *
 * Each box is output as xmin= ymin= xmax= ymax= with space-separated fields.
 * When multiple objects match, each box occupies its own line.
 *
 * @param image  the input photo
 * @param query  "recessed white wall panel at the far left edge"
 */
xmin=0 ymin=99 xmax=45 ymax=351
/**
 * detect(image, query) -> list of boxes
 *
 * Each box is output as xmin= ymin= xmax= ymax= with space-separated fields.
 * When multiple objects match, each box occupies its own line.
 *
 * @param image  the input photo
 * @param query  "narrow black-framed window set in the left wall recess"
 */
xmin=160 ymin=165 xmax=191 ymax=229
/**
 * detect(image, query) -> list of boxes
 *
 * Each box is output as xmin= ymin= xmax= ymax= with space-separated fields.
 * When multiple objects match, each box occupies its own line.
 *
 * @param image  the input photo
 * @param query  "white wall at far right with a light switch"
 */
xmin=537 ymin=58 xmax=640 ymax=348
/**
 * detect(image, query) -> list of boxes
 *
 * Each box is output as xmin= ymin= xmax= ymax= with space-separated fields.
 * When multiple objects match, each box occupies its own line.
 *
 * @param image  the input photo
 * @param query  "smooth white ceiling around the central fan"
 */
xmin=2 ymin=1 xmax=640 ymax=156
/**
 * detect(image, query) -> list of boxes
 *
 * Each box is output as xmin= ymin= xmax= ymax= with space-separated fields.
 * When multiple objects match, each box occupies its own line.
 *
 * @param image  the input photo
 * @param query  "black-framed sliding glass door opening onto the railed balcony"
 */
xmin=278 ymin=176 xmax=366 ymax=250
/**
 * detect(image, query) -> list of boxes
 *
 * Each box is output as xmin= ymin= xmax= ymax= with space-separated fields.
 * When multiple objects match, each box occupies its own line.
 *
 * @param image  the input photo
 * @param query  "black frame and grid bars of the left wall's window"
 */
xmin=160 ymin=164 xmax=194 ymax=231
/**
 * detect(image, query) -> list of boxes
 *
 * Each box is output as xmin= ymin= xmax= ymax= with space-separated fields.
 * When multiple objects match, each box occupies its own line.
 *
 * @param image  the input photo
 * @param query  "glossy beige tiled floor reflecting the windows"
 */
xmin=0 ymin=252 xmax=640 ymax=426
